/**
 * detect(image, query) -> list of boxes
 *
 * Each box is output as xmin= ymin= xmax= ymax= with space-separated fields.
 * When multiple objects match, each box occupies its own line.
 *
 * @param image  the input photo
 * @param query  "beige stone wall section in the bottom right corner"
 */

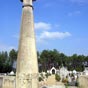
xmin=79 ymin=76 xmax=88 ymax=88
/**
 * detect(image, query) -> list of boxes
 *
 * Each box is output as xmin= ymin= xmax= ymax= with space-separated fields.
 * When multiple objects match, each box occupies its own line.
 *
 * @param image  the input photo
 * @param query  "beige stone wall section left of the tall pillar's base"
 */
xmin=0 ymin=76 xmax=16 ymax=88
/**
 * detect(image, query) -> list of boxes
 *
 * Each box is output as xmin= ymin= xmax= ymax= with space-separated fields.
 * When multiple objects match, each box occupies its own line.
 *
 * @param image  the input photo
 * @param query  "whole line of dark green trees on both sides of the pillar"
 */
xmin=0 ymin=49 xmax=88 ymax=72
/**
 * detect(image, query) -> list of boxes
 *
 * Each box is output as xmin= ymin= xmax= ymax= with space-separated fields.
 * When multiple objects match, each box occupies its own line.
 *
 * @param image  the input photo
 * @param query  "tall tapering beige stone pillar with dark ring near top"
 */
xmin=16 ymin=0 xmax=38 ymax=88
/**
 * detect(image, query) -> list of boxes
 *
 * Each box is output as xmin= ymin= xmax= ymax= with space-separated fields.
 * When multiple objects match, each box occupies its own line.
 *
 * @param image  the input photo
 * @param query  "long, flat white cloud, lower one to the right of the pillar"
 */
xmin=37 ymin=31 xmax=71 ymax=40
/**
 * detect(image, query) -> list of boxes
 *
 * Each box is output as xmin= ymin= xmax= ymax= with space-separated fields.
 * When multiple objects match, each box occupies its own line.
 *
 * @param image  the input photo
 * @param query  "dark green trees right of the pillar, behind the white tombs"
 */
xmin=38 ymin=49 xmax=88 ymax=71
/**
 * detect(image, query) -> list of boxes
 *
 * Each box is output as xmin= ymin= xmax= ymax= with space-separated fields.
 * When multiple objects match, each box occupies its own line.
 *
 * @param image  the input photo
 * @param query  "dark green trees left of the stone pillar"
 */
xmin=0 ymin=49 xmax=17 ymax=73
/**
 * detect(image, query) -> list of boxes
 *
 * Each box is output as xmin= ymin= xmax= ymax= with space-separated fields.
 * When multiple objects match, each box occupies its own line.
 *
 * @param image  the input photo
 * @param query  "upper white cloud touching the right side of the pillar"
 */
xmin=35 ymin=22 xmax=52 ymax=30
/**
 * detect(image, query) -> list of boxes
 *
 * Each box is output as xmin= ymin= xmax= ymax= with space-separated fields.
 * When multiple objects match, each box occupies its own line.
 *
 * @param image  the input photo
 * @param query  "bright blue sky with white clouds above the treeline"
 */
xmin=0 ymin=0 xmax=88 ymax=55
